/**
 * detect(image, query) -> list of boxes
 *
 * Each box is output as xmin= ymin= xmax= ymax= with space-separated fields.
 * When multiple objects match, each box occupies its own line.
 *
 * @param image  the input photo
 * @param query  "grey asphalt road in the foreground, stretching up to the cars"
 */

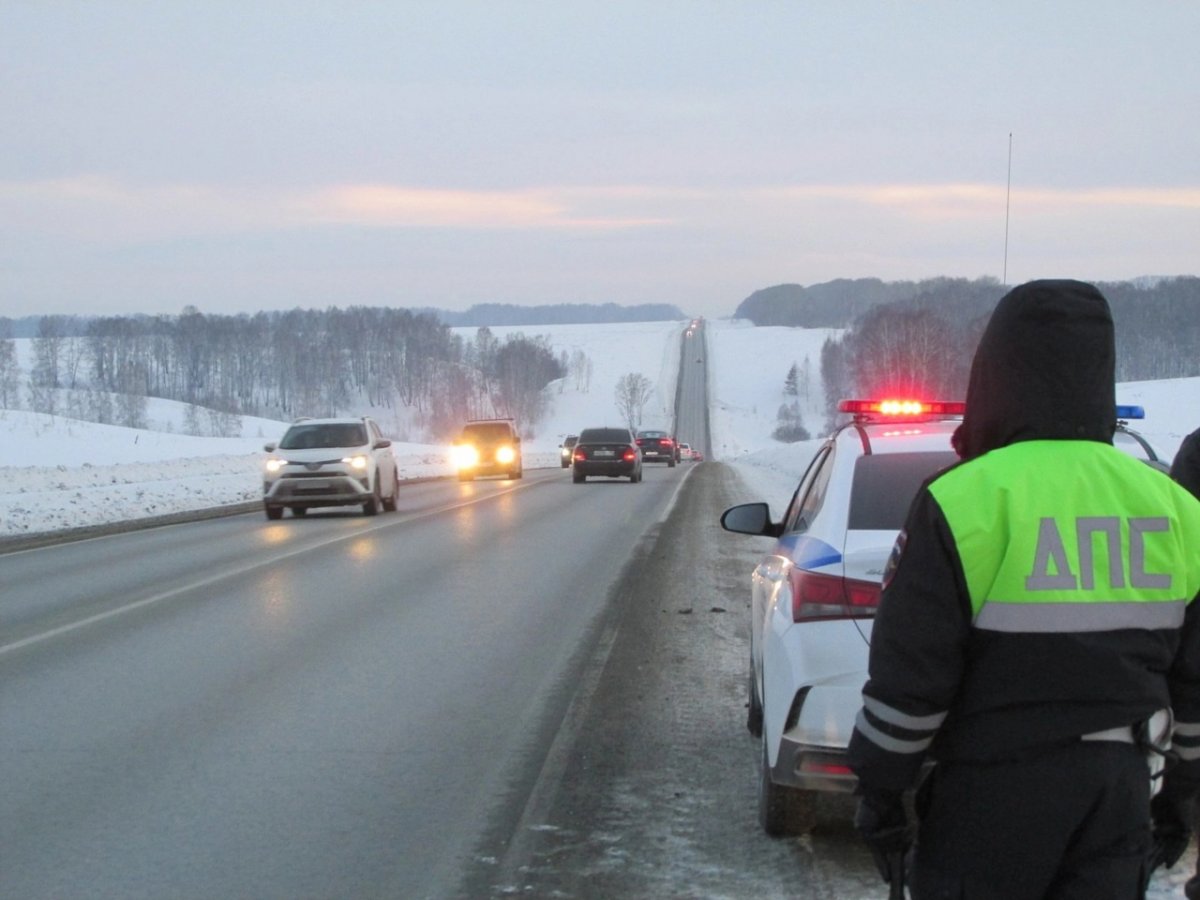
xmin=0 ymin=467 xmax=700 ymax=898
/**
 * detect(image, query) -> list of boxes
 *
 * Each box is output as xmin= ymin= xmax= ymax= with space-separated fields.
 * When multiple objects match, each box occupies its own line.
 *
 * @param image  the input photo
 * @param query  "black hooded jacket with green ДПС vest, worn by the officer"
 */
xmin=850 ymin=281 xmax=1200 ymax=790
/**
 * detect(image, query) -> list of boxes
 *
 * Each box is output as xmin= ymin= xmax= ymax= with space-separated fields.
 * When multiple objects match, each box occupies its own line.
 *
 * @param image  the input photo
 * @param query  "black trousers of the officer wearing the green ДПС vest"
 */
xmin=911 ymin=742 xmax=1151 ymax=900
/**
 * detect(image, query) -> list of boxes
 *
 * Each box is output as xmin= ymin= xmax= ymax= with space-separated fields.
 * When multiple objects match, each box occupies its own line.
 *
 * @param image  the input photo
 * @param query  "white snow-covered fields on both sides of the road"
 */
xmin=0 ymin=319 xmax=1200 ymax=538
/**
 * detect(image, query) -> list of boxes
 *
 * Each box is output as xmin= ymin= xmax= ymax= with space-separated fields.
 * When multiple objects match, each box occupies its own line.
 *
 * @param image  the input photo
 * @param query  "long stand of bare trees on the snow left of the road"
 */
xmin=0 ymin=307 xmax=573 ymax=439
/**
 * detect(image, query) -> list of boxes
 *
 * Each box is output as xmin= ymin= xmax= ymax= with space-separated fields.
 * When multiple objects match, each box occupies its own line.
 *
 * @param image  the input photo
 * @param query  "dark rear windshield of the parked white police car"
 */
xmin=850 ymin=450 xmax=959 ymax=532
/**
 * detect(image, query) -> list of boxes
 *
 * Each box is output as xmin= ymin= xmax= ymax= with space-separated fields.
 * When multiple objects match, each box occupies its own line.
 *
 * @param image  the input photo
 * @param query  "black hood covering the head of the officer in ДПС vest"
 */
xmin=954 ymin=281 xmax=1116 ymax=460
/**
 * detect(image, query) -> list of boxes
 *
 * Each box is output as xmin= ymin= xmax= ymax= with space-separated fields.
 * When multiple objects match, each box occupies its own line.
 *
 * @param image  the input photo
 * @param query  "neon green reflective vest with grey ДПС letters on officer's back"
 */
xmin=930 ymin=440 xmax=1200 ymax=634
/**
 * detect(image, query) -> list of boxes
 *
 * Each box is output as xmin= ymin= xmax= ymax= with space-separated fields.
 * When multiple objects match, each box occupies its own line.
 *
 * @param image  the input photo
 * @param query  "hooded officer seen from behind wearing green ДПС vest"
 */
xmin=850 ymin=281 xmax=1200 ymax=900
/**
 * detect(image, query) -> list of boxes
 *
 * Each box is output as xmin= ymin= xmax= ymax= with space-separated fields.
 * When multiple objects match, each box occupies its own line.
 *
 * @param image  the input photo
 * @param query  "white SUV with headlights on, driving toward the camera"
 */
xmin=263 ymin=416 xmax=400 ymax=518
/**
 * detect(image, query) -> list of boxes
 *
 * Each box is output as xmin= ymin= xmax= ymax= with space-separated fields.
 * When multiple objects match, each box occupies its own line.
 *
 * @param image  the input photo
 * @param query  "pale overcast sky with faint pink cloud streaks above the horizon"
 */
xmin=0 ymin=0 xmax=1200 ymax=317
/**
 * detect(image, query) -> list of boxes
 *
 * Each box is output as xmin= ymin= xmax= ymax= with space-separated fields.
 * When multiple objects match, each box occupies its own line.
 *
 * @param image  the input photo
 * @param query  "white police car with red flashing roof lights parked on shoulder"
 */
xmin=721 ymin=400 xmax=1162 ymax=835
